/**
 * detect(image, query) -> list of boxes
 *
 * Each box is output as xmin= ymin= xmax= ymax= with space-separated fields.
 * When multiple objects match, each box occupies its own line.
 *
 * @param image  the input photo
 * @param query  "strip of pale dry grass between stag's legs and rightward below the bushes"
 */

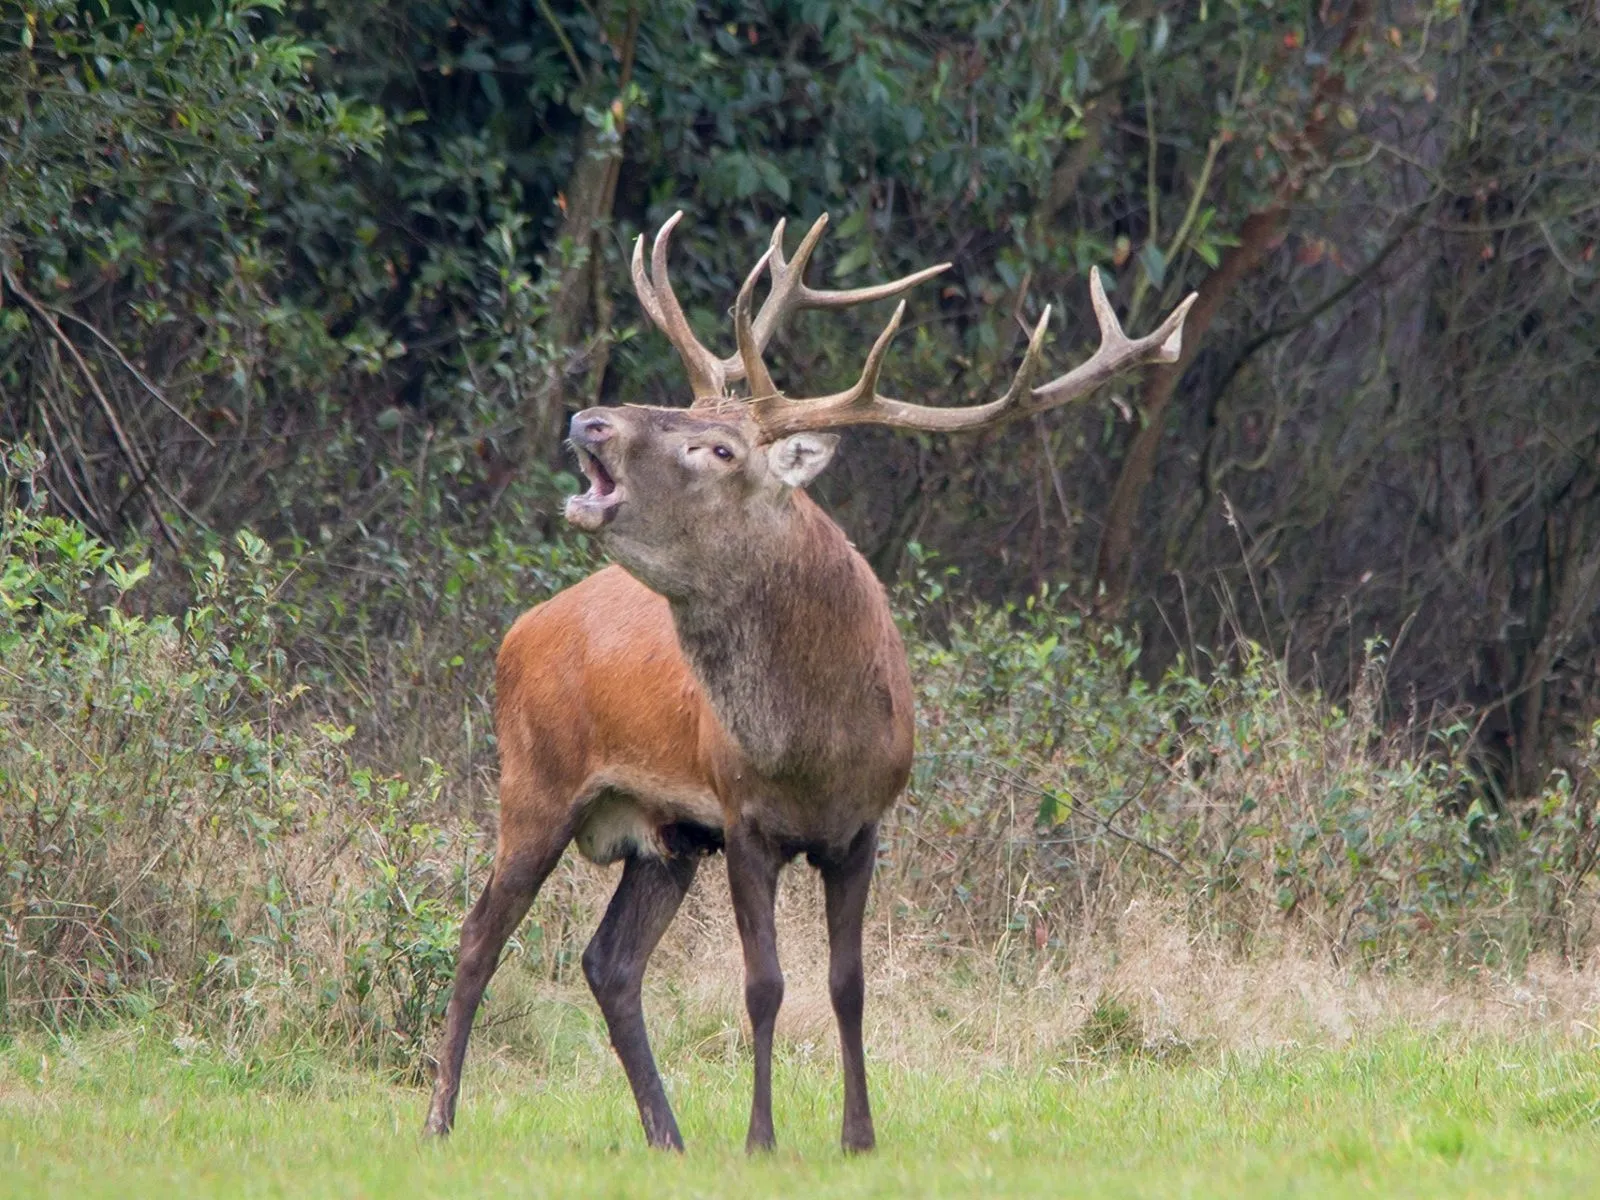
xmin=475 ymin=859 xmax=1600 ymax=1069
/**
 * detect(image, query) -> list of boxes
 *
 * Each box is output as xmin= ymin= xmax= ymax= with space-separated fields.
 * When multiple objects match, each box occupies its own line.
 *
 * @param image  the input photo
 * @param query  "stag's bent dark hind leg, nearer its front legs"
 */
xmin=584 ymin=853 xmax=699 ymax=1150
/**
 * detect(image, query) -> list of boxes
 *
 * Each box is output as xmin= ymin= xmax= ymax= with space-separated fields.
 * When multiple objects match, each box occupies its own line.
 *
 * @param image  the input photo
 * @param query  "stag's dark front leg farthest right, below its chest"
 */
xmin=821 ymin=822 xmax=878 ymax=1154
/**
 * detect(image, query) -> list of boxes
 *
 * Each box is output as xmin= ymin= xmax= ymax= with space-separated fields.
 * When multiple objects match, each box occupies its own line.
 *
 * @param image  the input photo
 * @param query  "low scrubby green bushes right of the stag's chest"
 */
xmin=890 ymin=555 xmax=1600 ymax=966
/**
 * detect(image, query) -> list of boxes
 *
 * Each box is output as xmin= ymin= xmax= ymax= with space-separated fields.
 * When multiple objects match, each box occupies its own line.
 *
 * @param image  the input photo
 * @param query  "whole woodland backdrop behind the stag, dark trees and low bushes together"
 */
xmin=0 ymin=0 xmax=1600 ymax=1062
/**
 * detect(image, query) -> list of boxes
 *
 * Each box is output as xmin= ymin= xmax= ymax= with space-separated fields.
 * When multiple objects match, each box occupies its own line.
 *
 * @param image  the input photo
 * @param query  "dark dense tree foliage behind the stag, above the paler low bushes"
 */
xmin=0 ymin=0 xmax=1600 ymax=792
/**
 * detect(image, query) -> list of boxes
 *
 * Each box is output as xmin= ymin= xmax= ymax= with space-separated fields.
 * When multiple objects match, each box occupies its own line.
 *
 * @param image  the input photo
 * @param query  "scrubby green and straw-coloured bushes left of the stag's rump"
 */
xmin=0 ymin=454 xmax=483 ymax=1070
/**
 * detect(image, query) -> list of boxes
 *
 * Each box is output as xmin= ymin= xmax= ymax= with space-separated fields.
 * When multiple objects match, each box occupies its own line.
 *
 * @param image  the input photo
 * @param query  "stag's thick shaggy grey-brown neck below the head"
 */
xmin=672 ymin=494 xmax=904 ymax=778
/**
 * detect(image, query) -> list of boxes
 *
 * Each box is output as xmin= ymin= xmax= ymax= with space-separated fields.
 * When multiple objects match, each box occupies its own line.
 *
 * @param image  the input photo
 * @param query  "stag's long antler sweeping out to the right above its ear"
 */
xmin=733 ymin=267 xmax=1197 ymax=440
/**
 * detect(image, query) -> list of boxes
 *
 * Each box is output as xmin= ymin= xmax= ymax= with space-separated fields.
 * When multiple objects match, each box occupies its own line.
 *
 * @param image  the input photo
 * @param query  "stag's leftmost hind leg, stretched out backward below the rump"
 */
xmin=422 ymin=810 xmax=571 ymax=1134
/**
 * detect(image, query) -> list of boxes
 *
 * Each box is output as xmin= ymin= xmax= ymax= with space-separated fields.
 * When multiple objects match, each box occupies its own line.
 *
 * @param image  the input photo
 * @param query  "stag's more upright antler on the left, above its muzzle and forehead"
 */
xmin=634 ymin=211 xmax=950 ymax=408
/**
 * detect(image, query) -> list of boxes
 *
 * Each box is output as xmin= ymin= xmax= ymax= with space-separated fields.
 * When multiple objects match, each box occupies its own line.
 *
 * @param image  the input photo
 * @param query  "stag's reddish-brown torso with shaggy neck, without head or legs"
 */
xmin=494 ymin=493 xmax=912 ymax=864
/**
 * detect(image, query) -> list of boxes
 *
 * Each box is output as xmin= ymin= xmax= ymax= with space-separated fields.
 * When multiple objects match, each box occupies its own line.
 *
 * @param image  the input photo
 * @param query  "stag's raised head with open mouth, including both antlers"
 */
xmin=566 ymin=213 xmax=1194 ymax=595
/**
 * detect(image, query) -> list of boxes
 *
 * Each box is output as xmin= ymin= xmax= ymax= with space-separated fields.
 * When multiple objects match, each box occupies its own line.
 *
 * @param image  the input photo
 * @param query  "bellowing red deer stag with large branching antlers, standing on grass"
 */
xmin=426 ymin=214 xmax=1194 ymax=1150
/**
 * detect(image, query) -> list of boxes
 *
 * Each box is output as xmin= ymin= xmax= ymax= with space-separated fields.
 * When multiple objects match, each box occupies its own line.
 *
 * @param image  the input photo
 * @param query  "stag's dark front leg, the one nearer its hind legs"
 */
xmin=725 ymin=821 xmax=784 ymax=1152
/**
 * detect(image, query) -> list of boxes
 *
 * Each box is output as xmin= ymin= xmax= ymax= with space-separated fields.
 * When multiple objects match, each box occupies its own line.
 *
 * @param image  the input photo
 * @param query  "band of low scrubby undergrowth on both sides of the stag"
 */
xmin=0 ymin=464 xmax=1600 ymax=1078
